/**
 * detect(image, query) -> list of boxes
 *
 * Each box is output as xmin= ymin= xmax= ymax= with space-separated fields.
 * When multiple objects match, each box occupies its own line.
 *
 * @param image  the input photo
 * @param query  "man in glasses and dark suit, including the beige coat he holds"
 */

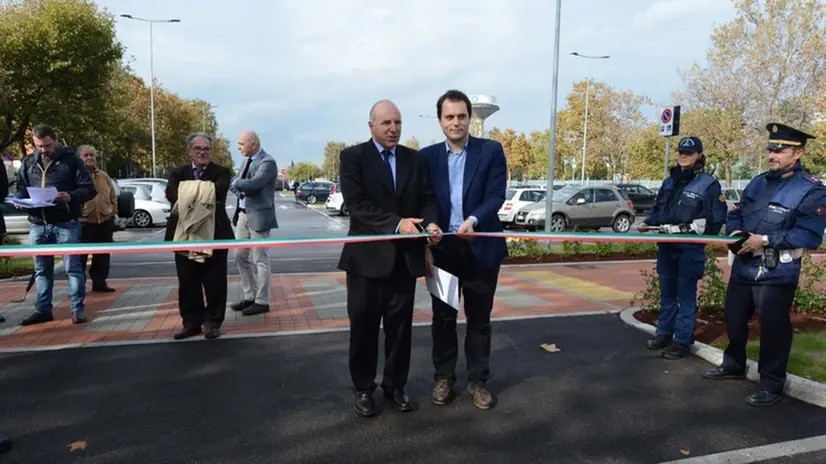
xmin=164 ymin=132 xmax=235 ymax=340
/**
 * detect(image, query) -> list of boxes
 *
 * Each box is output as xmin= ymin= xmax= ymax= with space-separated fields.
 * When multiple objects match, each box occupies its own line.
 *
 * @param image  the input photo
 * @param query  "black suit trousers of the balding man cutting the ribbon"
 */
xmin=347 ymin=253 xmax=416 ymax=393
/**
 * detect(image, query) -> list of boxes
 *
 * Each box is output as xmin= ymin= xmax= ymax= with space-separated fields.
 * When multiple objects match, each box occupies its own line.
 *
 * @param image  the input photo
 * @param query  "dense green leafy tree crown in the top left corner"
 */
xmin=0 ymin=0 xmax=123 ymax=151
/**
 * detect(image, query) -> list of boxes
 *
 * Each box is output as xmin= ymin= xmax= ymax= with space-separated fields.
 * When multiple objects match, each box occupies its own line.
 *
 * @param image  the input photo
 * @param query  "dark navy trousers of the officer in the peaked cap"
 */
xmin=722 ymin=280 xmax=797 ymax=393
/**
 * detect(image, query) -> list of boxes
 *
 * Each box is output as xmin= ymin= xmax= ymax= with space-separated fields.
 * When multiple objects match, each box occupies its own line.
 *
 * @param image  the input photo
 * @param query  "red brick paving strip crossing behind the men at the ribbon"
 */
xmin=0 ymin=261 xmax=784 ymax=349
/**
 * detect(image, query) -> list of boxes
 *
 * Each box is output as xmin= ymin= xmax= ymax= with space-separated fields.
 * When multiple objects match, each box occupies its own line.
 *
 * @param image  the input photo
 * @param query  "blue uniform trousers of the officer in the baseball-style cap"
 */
xmin=656 ymin=245 xmax=705 ymax=345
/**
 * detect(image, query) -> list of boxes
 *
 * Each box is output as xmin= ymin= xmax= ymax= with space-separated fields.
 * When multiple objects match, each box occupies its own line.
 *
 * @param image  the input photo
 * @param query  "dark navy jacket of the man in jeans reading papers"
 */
xmin=15 ymin=145 xmax=97 ymax=225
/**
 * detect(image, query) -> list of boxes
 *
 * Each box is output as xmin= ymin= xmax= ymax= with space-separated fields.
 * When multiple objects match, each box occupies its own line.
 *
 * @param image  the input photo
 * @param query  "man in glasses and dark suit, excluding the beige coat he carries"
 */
xmin=164 ymin=132 xmax=235 ymax=340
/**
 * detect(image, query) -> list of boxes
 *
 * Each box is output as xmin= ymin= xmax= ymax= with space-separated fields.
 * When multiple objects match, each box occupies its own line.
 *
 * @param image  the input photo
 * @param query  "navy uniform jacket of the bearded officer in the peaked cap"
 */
xmin=726 ymin=162 xmax=826 ymax=285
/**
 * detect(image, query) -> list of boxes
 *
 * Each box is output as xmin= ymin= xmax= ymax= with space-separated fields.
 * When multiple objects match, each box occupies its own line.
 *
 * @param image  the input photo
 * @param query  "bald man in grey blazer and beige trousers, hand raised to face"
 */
xmin=230 ymin=130 xmax=278 ymax=316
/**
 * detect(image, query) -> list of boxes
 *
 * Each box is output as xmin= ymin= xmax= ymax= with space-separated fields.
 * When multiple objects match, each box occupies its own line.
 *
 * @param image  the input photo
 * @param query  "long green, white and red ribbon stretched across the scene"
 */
xmin=0 ymin=232 xmax=739 ymax=257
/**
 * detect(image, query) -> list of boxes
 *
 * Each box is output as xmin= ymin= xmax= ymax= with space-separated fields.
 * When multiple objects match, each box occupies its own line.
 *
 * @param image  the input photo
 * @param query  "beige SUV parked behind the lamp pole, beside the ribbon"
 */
xmin=515 ymin=185 xmax=636 ymax=233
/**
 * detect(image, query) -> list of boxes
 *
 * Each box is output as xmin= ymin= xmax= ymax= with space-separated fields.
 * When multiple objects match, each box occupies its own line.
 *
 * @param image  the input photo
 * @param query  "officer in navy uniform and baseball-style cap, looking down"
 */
xmin=639 ymin=137 xmax=727 ymax=359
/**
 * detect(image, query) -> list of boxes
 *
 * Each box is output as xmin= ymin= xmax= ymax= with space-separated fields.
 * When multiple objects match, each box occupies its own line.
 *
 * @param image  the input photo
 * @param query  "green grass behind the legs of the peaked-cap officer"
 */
xmin=712 ymin=332 xmax=826 ymax=382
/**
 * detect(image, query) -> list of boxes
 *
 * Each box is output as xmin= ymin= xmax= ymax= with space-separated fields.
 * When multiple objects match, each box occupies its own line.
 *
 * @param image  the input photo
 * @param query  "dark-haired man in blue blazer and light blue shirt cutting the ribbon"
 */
xmin=420 ymin=90 xmax=508 ymax=409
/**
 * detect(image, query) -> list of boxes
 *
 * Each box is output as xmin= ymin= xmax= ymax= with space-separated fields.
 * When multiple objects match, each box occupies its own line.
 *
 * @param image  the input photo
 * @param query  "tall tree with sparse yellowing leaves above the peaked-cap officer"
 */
xmin=679 ymin=0 xmax=826 ymax=181
